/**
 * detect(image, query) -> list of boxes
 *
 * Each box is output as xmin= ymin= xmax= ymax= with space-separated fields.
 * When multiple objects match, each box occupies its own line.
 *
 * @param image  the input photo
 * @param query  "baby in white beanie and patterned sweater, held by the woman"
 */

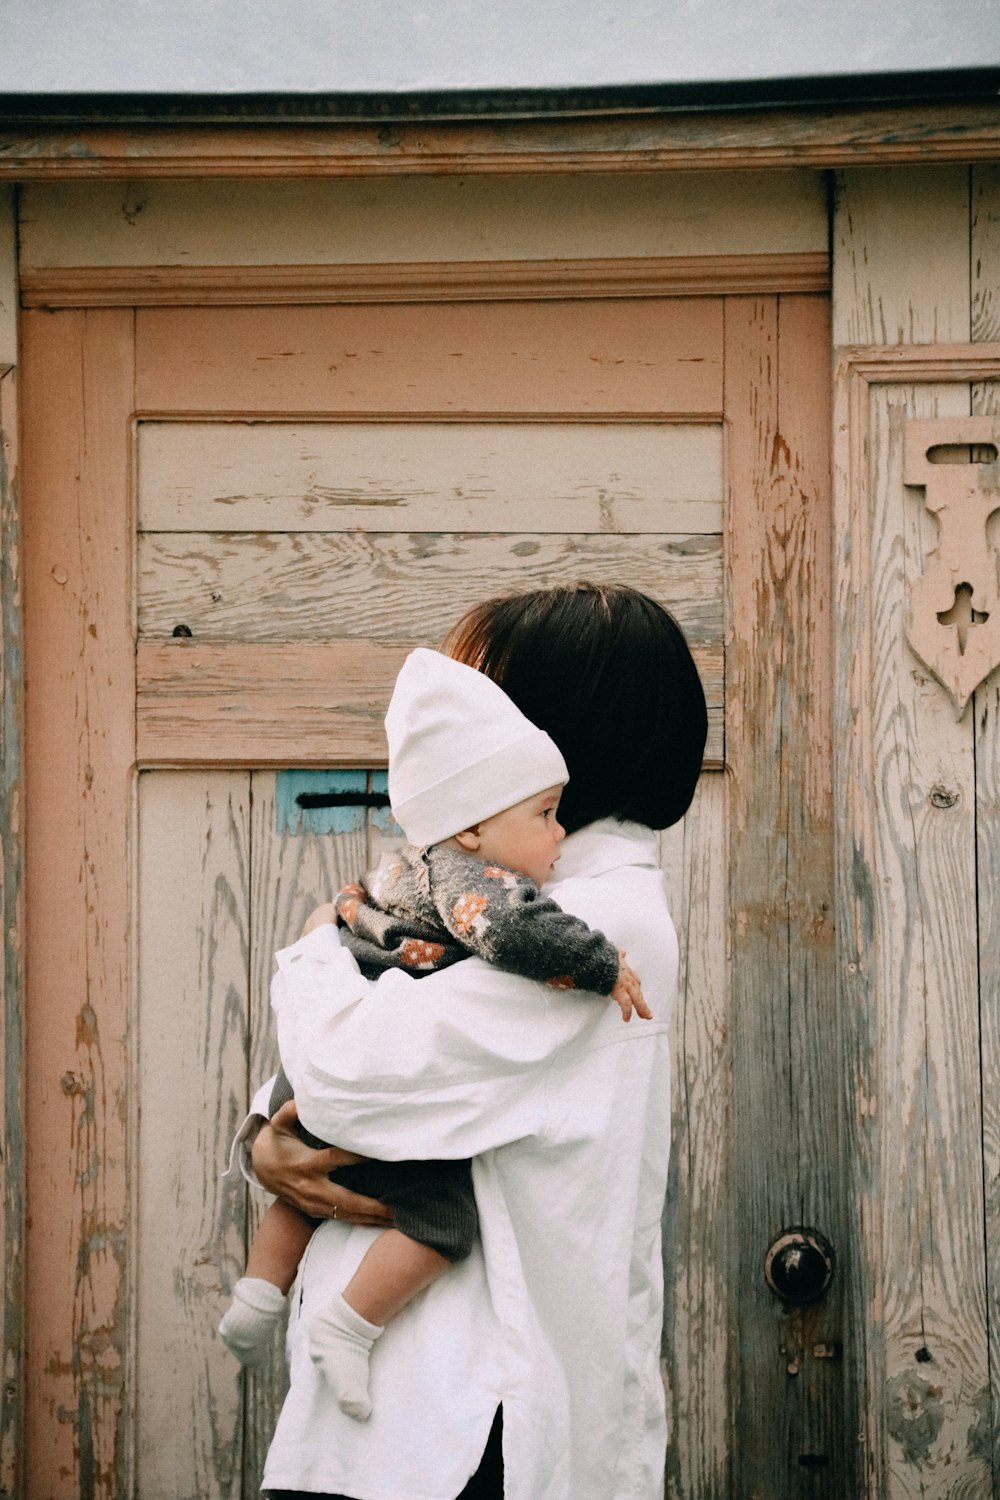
xmin=219 ymin=650 xmax=651 ymax=1421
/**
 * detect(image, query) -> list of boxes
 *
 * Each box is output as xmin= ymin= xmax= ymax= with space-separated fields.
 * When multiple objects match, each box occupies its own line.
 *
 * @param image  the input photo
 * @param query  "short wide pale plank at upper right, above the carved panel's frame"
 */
xmin=834 ymin=165 xmax=969 ymax=345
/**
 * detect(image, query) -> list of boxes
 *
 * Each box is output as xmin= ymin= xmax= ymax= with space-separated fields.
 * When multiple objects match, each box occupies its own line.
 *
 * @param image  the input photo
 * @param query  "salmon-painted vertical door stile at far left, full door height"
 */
xmin=22 ymin=311 xmax=135 ymax=1500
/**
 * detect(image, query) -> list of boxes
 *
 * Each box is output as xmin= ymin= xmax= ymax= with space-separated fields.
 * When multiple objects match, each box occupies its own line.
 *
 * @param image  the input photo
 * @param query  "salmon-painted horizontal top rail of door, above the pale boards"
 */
xmin=136 ymin=297 xmax=723 ymax=419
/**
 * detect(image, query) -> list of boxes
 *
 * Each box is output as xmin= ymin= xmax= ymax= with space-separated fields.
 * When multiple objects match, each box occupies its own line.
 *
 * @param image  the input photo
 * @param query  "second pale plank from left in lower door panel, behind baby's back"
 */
xmin=243 ymin=771 xmax=369 ymax=1500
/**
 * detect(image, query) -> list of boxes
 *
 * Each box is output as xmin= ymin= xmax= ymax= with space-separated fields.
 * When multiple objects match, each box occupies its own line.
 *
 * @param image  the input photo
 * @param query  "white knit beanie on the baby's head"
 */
xmin=385 ymin=647 xmax=570 ymax=848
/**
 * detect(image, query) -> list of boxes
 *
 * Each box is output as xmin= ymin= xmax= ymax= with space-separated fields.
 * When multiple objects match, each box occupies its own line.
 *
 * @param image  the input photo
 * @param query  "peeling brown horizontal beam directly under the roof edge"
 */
xmin=0 ymin=101 xmax=1000 ymax=182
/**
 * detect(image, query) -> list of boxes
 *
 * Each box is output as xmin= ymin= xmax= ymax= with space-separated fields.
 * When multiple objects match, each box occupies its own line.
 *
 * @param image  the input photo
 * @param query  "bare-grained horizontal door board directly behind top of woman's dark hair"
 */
xmin=136 ymin=531 xmax=723 ymax=644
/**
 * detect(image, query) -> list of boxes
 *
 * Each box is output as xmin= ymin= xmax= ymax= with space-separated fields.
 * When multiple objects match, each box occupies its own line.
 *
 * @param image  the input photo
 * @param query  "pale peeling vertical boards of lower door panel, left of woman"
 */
xmin=135 ymin=771 xmax=401 ymax=1500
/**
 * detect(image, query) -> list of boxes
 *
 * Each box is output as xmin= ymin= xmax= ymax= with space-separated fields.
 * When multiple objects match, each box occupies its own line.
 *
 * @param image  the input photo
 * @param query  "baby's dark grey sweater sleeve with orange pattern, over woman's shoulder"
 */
xmin=430 ymin=851 xmax=619 ymax=995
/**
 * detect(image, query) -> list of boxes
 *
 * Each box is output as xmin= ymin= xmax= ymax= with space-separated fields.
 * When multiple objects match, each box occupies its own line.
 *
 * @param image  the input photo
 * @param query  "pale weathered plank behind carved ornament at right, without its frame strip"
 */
xmin=870 ymin=387 xmax=990 ymax=1497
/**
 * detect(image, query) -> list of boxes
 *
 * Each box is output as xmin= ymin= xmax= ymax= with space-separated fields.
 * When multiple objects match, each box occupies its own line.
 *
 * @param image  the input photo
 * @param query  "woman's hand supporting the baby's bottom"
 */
xmin=250 ymin=1100 xmax=393 ymax=1229
